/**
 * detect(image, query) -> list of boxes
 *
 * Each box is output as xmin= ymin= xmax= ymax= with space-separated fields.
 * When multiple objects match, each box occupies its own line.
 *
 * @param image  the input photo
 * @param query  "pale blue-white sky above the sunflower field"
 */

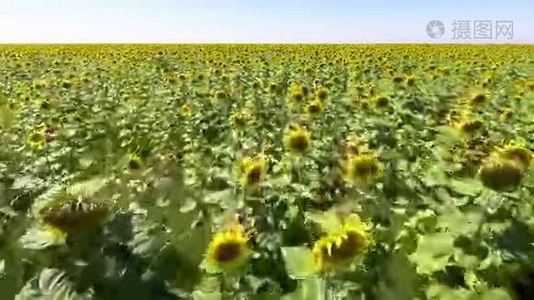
xmin=0 ymin=0 xmax=534 ymax=43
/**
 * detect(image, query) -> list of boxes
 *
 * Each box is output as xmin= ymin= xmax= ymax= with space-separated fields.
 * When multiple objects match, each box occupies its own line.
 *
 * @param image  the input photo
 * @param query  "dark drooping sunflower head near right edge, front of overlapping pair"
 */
xmin=479 ymin=154 xmax=523 ymax=191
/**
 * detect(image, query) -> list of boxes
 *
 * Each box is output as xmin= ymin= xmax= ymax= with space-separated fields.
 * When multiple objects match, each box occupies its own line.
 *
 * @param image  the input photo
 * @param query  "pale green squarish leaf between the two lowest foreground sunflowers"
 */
xmin=282 ymin=247 xmax=316 ymax=279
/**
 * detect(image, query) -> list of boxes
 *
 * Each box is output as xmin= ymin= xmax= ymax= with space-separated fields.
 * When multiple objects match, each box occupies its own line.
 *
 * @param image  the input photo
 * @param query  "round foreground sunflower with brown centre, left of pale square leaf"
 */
xmin=205 ymin=224 xmax=252 ymax=273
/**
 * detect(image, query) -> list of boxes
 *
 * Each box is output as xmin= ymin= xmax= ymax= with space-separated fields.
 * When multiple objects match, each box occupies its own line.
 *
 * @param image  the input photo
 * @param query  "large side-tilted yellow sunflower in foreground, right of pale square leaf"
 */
xmin=312 ymin=214 xmax=372 ymax=272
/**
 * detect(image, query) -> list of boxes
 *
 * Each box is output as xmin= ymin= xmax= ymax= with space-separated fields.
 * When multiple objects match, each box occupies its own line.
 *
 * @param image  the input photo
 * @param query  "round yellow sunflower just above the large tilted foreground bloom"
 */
xmin=344 ymin=153 xmax=383 ymax=188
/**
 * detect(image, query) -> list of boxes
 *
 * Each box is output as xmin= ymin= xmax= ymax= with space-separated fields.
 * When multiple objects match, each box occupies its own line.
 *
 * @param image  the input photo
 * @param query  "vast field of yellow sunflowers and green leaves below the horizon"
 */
xmin=0 ymin=44 xmax=534 ymax=300
